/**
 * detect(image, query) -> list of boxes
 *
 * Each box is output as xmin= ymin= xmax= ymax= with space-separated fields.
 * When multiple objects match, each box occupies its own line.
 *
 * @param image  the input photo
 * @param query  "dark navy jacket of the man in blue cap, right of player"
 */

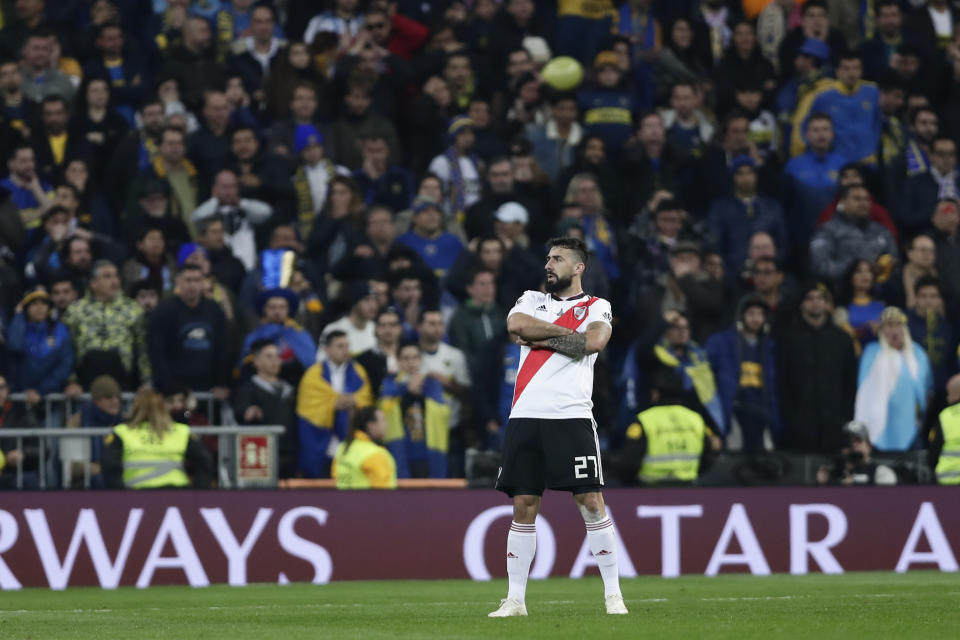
xmin=707 ymin=196 xmax=788 ymax=275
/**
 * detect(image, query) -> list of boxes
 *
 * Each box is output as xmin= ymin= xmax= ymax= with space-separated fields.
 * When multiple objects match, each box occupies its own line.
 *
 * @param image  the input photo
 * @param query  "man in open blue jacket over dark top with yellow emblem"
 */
xmin=706 ymin=296 xmax=780 ymax=452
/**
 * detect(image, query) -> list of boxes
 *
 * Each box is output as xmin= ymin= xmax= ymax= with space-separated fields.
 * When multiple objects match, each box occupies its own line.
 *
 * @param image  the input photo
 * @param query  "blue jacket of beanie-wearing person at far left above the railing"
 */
xmin=7 ymin=312 xmax=73 ymax=395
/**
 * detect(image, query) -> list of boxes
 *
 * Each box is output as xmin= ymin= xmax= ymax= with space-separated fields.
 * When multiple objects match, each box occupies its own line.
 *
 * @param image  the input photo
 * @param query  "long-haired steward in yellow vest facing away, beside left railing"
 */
xmin=101 ymin=389 xmax=213 ymax=489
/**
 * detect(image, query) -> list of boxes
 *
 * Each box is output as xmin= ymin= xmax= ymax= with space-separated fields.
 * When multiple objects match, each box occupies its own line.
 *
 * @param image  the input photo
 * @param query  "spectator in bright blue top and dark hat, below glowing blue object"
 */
xmin=240 ymin=287 xmax=317 ymax=384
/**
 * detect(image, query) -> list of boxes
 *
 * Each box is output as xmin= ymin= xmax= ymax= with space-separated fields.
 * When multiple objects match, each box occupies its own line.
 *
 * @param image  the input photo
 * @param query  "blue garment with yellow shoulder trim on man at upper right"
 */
xmin=793 ymin=81 xmax=883 ymax=162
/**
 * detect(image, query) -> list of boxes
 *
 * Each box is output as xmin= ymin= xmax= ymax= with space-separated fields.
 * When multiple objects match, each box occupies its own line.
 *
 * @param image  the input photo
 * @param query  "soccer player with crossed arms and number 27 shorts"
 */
xmin=489 ymin=238 xmax=627 ymax=618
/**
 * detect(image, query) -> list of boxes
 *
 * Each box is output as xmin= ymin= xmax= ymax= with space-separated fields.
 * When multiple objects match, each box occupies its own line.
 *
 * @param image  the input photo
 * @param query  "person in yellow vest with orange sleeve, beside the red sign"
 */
xmin=330 ymin=407 xmax=397 ymax=489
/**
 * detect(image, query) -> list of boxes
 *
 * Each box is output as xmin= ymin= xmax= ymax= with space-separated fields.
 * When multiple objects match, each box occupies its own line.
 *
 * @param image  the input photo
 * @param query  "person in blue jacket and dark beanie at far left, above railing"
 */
xmin=7 ymin=289 xmax=73 ymax=404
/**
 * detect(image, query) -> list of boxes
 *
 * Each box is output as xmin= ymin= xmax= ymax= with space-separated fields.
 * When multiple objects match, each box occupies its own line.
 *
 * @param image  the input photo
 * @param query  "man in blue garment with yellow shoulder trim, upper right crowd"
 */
xmin=790 ymin=52 xmax=883 ymax=164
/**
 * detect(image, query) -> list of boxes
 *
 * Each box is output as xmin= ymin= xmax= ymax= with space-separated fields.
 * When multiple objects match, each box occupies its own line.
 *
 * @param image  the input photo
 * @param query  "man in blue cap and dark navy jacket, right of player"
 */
xmin=707 ymin=156 xmax=787 ymax=274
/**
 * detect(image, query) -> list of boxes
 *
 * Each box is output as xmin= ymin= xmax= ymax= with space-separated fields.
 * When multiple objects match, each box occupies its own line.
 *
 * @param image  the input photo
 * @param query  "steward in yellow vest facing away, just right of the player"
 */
xmin=621 ymin=371 xmax=721 ymax=485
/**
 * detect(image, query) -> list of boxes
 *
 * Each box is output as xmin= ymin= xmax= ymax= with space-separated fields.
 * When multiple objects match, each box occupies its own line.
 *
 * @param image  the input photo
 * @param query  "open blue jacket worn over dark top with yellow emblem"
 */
xmin=706 ymin=327 xmax=780 ymax=438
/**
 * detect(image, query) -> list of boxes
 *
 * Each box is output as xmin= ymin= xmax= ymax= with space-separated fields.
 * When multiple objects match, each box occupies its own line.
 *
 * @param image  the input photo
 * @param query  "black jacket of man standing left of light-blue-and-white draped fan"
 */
xmin=776 ymin=319 xmax=857 ymax=453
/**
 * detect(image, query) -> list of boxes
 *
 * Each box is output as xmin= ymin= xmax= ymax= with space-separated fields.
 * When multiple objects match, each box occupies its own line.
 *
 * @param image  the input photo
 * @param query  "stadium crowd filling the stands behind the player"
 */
xmin=0 ymin=0 xmax=960 ymax=482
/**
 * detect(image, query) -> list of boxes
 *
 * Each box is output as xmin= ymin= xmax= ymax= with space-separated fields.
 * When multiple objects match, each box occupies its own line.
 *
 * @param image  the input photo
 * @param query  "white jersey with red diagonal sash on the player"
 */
xmin=507 ymin=291 xmax=612 ymax=419
